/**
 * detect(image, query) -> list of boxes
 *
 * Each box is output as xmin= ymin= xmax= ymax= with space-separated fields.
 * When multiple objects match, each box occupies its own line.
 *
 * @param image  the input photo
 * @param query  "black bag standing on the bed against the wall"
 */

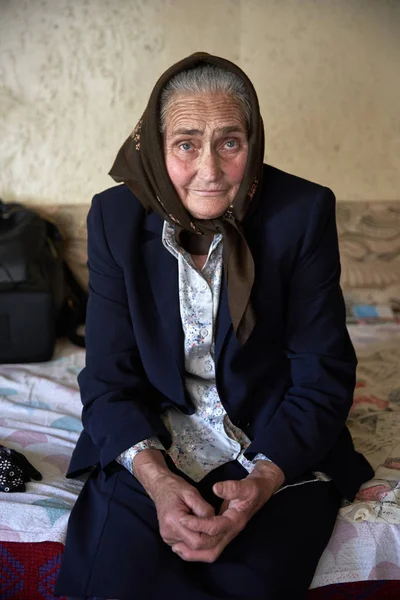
xmin=0 ymin=201 xmax=87 ymax=363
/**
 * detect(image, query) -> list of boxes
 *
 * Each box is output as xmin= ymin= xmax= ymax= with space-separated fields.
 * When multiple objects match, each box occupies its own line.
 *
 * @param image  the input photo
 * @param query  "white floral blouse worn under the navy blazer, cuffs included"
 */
xmin=117 ymin=222 xmax=269 ymax=481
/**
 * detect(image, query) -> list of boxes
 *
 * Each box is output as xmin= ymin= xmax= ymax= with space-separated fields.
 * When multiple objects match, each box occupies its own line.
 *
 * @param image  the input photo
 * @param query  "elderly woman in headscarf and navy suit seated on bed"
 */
xmin=57 ymin=53 xmax=372 ymax=600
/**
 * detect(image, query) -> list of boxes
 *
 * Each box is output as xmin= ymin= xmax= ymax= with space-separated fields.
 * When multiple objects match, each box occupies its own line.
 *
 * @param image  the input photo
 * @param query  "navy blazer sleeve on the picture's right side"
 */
xmin=246 ymin=188 xmax=357 ymax=480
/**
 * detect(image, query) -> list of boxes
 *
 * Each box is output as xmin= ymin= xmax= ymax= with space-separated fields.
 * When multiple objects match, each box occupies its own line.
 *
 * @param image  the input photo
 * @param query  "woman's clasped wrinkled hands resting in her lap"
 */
xmin=153 ymin=461 xmax=284 ymax=563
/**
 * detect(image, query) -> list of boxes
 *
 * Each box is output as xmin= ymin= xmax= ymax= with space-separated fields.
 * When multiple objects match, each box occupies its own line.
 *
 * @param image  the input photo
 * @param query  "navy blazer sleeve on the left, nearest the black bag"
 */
xmin=75 ymin=196 xmax=170 ymax=468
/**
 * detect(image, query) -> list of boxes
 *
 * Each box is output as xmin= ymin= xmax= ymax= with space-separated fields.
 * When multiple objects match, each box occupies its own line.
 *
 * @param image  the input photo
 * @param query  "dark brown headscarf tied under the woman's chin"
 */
xmin=109 ymin=52 xmax=264 ymax=344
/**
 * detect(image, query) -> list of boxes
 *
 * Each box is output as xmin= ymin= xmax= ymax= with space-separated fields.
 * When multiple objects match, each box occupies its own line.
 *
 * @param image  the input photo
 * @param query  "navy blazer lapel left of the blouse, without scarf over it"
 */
xmin=142 ymin=213 xmax=184 ymax=374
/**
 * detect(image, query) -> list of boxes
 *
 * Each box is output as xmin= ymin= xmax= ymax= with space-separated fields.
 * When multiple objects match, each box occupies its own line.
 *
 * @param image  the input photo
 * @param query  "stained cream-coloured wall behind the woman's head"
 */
xmin=0 ymin=0 xmax=400 ymax=203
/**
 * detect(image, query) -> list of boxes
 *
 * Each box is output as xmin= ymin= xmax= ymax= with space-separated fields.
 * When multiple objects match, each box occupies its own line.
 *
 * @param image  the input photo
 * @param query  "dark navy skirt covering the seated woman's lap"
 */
xmin=56 ymin=461 xmax=342 ymax=600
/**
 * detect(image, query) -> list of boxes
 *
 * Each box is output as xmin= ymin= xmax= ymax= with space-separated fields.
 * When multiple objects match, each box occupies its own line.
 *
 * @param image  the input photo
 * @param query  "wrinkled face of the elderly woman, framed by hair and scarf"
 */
xmin=164 ymin=93 xmax=248 ymax=219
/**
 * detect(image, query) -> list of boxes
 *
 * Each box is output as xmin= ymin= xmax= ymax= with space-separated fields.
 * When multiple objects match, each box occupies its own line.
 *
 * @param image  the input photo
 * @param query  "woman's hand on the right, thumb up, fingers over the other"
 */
xmin=172 ymin=461 xmax=284 ymax=563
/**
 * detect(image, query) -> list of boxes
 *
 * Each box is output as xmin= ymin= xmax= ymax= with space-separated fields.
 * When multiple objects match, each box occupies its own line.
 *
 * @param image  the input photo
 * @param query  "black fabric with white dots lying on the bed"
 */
xmin=0 ymin=445 xmax=42 ymax=492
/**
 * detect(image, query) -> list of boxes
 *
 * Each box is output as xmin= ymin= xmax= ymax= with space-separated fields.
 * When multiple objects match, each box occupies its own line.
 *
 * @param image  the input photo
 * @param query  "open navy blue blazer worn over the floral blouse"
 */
xmin=68 ymin=166 xmax=373 ymax=500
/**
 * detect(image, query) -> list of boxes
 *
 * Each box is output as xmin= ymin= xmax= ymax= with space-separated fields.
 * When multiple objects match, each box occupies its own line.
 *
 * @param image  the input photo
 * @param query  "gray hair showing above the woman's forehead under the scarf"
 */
xmin=160 ymin=64 xmax=251 ymax=133
